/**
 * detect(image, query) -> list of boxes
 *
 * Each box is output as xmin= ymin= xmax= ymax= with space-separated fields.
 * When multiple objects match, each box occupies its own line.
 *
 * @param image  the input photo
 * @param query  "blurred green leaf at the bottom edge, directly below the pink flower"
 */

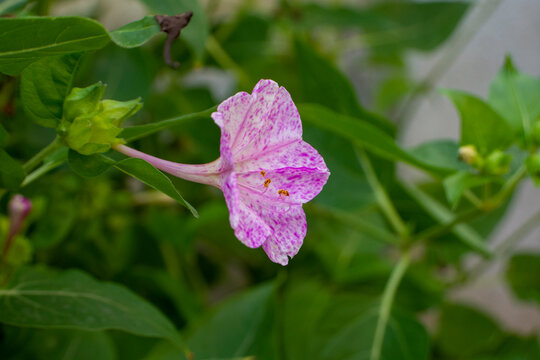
xmin=188 ymin=284 xmax=275 ymax=359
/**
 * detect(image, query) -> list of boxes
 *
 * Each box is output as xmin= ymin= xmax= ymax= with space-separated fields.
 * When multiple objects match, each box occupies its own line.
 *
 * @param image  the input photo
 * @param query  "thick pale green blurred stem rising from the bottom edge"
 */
xmin=369 ymin=251 xmax=411 ymax=360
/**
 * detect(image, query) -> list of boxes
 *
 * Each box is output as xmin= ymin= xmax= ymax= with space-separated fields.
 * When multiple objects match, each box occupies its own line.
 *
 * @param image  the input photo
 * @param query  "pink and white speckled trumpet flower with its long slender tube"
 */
xmin=116 ymin=80 xmax=330 ymax=265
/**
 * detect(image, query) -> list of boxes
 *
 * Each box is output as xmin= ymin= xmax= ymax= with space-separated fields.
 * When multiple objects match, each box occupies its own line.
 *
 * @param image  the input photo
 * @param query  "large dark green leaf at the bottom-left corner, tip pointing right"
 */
xmin=0 ymin=268 xmax=182 ymax=346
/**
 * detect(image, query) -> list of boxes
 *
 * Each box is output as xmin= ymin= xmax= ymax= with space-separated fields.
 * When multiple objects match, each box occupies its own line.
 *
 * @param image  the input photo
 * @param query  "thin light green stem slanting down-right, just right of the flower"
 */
xmin=356 ymin=149 xmax=408 ymax=237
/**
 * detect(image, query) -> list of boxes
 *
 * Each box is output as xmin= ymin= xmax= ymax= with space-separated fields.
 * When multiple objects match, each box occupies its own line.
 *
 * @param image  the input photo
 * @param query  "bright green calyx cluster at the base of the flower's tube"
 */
xmin=59 ymin=83 xmax=142 ymax=155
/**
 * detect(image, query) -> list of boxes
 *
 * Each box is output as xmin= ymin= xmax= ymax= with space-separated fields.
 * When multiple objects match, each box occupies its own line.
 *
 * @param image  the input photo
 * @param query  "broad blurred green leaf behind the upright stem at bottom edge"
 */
xmin=280 ymin=279 xmax=429 ymax=360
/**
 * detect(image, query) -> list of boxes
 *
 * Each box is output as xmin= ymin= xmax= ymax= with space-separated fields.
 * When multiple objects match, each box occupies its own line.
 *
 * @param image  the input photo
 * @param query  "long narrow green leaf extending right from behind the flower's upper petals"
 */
xmin=298 ymin=104 xmax=450 ymax=172
